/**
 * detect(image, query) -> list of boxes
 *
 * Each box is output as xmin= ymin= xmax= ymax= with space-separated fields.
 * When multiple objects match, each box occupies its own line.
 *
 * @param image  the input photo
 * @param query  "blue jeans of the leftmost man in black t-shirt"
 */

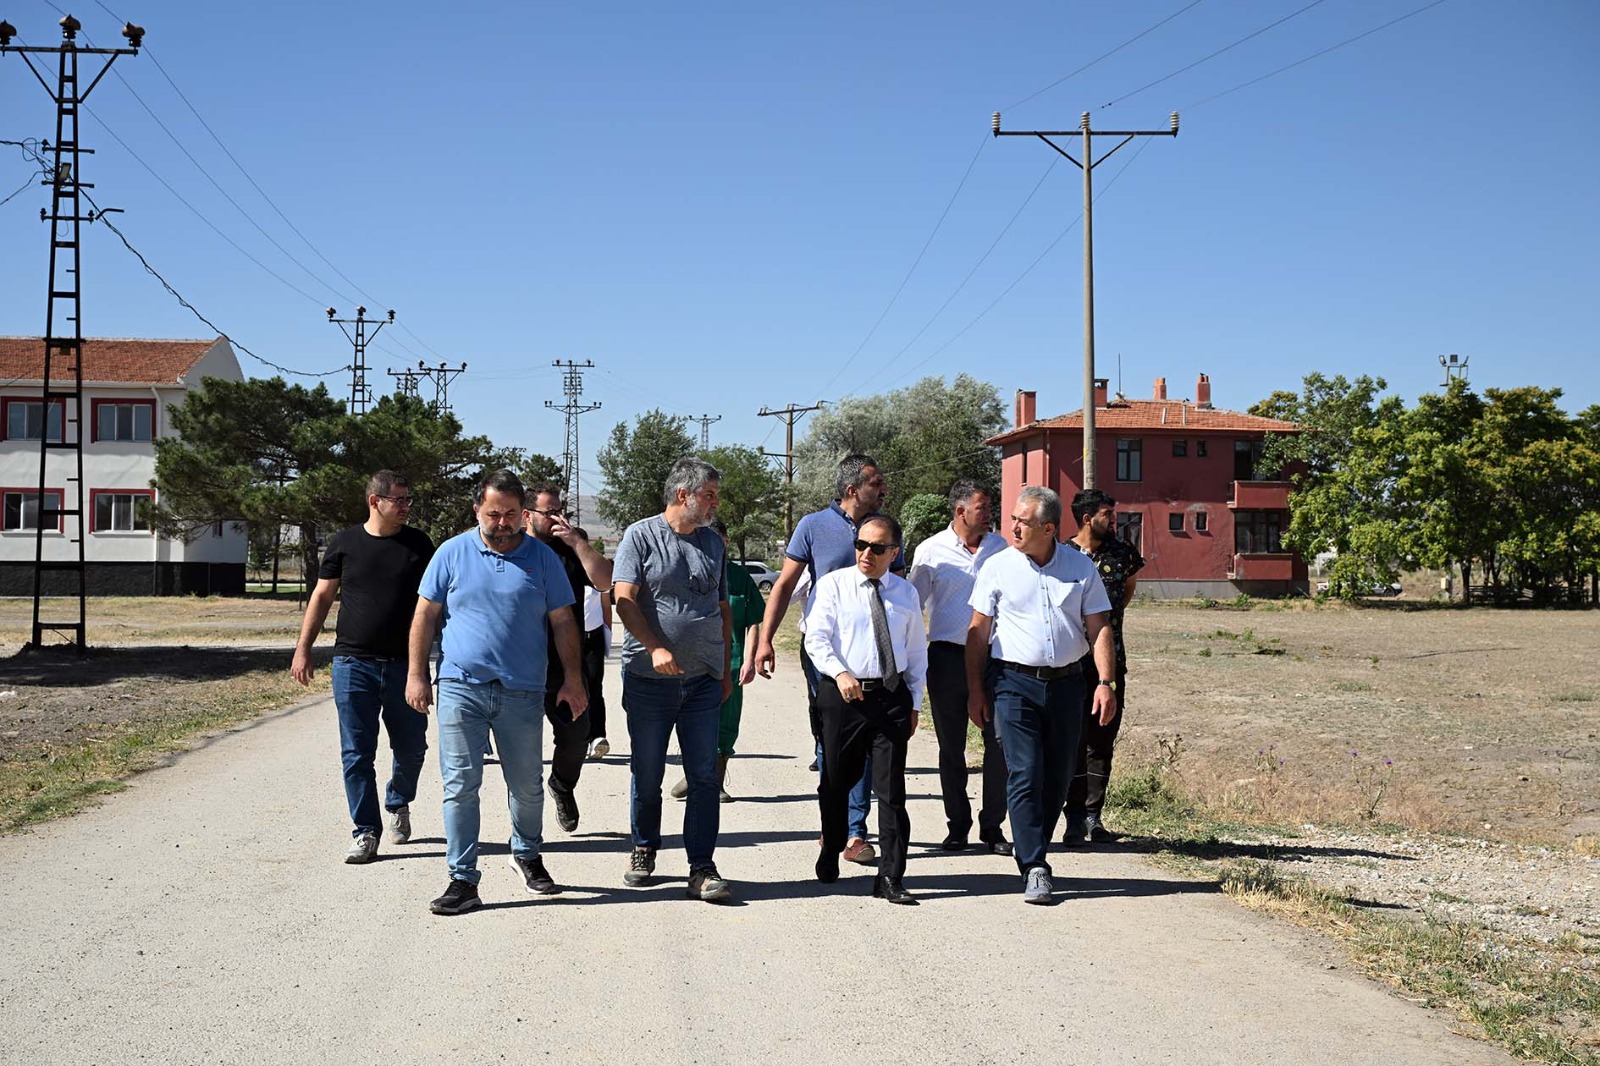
xmin=333 ymin=655 xmax=427 ymax=836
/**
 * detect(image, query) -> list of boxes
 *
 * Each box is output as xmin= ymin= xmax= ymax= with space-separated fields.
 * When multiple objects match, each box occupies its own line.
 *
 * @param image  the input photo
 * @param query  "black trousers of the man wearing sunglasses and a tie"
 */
xmin=816 ymin=677 xmax=917 ymax=879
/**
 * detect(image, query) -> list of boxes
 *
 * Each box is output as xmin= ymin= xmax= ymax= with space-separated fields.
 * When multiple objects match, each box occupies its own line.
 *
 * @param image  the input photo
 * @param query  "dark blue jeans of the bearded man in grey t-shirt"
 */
xmin=622 ymin=671 xmax=722 ymax=871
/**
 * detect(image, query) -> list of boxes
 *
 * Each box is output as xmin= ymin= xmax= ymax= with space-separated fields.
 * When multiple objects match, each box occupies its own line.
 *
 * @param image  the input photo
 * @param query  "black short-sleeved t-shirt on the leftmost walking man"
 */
xmin=317 ymin=525 xmax=434 ymax=659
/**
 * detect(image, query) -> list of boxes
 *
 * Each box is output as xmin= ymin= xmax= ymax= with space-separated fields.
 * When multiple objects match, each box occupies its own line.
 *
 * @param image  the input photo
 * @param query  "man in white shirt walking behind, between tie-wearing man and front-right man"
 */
xmin=909 ymin=480 xmax=1011 ymax=855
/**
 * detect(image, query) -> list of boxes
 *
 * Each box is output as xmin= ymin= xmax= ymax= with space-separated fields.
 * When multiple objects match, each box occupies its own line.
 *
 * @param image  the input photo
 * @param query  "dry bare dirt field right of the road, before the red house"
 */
xmin=1118 ymin=602 xmax=1600 ymax=848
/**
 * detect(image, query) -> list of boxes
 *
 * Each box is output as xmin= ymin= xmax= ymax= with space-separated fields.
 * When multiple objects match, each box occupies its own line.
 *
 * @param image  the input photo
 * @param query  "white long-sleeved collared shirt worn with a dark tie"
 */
xmin=805 ymin=567 xmax=928 ymax=707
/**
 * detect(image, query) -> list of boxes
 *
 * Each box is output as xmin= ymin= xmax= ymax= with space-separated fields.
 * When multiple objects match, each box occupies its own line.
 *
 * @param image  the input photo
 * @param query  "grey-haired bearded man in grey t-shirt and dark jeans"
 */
xmin=613 ymin=458 xmax=733 ymax=903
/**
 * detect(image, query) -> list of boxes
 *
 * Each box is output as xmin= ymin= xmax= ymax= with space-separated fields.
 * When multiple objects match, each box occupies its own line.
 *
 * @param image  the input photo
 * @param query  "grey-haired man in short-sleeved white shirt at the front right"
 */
xmin=966 ymin=485 xmax=1117 ymax=904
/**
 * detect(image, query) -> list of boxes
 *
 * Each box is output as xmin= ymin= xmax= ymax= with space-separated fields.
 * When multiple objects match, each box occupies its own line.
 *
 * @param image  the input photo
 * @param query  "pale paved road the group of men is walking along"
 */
xmin=0 ymin=664 xmax=1509 ymax=1066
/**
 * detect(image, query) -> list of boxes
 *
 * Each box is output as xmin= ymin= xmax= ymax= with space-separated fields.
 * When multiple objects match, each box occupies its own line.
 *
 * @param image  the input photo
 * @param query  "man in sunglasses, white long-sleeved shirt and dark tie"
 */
xmin=805 ymin=515 xmax=928 ymax=903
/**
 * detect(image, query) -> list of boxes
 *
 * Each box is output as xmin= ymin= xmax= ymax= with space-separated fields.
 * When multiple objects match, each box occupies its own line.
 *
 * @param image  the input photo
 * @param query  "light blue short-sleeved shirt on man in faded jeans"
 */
xmin=418 ymin=527 xmax=574 ymax=691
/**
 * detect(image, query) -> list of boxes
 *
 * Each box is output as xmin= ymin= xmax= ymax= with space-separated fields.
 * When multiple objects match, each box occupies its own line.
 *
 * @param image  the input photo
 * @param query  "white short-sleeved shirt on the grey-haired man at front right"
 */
xmin=968 ymin=544 xmax=1110 ymax=666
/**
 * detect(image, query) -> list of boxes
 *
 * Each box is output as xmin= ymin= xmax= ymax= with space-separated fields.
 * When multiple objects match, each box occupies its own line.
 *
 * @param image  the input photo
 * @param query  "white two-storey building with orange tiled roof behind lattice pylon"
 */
xmin=0 ymin=336 xmax=248 ymax=595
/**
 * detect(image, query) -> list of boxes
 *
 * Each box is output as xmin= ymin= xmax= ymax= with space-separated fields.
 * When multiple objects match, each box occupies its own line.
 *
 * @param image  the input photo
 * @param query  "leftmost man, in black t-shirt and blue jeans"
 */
xmin=290 ymin=471 xmax=434 ymax=863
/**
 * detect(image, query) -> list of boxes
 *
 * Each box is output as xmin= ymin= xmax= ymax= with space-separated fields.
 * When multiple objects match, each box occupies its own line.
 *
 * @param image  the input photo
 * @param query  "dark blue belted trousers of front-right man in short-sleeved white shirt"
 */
xmin=990 ymin=666 xmax=1083 ymax=874
